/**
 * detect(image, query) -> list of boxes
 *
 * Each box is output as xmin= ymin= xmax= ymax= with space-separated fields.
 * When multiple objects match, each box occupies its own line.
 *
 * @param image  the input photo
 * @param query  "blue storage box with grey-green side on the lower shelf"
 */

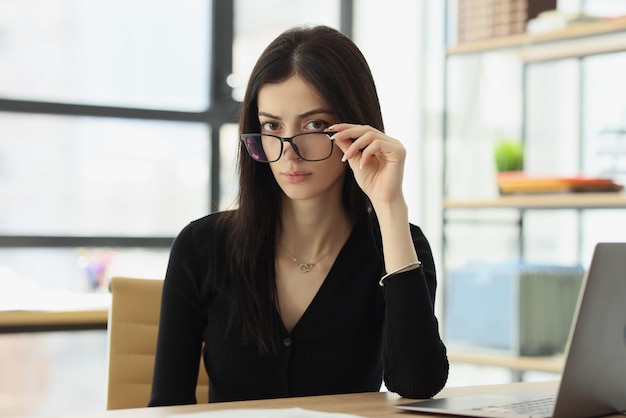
xmin=443 ymin=264 xmax=584 ymax=355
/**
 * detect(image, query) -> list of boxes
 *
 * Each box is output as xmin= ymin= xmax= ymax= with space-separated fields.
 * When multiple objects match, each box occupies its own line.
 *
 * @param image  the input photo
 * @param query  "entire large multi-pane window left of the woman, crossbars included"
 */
xmin=0 ymin=0 xmax=216 ymax=294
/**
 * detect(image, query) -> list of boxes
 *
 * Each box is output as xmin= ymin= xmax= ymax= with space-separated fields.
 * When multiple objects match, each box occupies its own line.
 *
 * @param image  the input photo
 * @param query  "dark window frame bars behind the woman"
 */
xmin=0 ymin=0 xmax=354 ymax=249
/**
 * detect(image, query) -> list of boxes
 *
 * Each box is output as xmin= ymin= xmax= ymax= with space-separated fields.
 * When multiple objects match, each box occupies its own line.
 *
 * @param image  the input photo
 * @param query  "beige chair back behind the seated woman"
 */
xmin=107 ymin=277 xmax=209 ymax=409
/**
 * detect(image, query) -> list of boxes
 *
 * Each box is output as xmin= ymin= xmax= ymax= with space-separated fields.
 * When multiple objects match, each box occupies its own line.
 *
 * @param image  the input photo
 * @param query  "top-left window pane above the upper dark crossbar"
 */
xmin=0 ymin=0 xmax=211 ymax=110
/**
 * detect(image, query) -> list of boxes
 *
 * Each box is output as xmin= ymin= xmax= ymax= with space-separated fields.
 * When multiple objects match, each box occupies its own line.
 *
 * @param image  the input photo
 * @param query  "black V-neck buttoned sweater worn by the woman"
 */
xmin=150 ymin=214 xmax=448 ymax=406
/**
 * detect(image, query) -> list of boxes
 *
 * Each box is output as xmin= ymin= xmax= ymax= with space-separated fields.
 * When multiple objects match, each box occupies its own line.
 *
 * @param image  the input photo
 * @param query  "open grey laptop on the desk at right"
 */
xmin=396 ymin=243 xmax=626 ymax=418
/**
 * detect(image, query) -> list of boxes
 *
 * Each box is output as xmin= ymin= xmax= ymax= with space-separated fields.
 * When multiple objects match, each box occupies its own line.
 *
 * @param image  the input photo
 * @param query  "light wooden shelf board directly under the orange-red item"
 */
xmin=443 ymin=193 xmax=626 ymax=209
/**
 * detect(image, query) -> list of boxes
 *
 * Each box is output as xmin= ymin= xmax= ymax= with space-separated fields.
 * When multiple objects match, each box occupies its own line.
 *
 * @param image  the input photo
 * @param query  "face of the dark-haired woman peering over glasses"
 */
xmin=257 ymin=76 xmax=347 ymax=204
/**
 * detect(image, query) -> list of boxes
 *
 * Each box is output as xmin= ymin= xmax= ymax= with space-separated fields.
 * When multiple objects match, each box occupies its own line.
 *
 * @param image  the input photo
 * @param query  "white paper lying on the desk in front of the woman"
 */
xmin=171 ymin=408 xmax=363 ymax=418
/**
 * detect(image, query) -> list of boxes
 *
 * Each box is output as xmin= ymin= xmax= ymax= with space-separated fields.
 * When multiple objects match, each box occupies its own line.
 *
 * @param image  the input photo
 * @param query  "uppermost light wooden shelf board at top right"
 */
xmin=447 ymin=19 xmax=626 ymax=62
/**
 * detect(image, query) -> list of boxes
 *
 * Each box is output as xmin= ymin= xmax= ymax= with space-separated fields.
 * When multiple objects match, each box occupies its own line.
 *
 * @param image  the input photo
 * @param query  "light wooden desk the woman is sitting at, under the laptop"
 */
xmin=39 ymin=381 xmax=623 ymax=418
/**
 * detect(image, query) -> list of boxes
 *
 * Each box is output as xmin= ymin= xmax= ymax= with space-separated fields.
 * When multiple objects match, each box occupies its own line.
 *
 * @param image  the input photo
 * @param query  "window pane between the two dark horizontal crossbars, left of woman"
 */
xmin=0 ymin=113 xmax=210 ymax=236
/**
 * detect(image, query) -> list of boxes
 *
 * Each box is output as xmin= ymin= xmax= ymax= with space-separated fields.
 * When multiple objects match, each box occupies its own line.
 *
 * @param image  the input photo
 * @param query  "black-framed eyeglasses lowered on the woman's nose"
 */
xmin=241 ymin=132 xmax=334 ymax=163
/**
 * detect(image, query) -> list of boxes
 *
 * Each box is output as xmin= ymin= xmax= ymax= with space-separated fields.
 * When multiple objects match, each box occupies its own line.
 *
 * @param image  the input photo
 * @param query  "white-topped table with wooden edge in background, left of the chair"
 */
xmin=0 ymin=291 xmax=111 ymax=334
